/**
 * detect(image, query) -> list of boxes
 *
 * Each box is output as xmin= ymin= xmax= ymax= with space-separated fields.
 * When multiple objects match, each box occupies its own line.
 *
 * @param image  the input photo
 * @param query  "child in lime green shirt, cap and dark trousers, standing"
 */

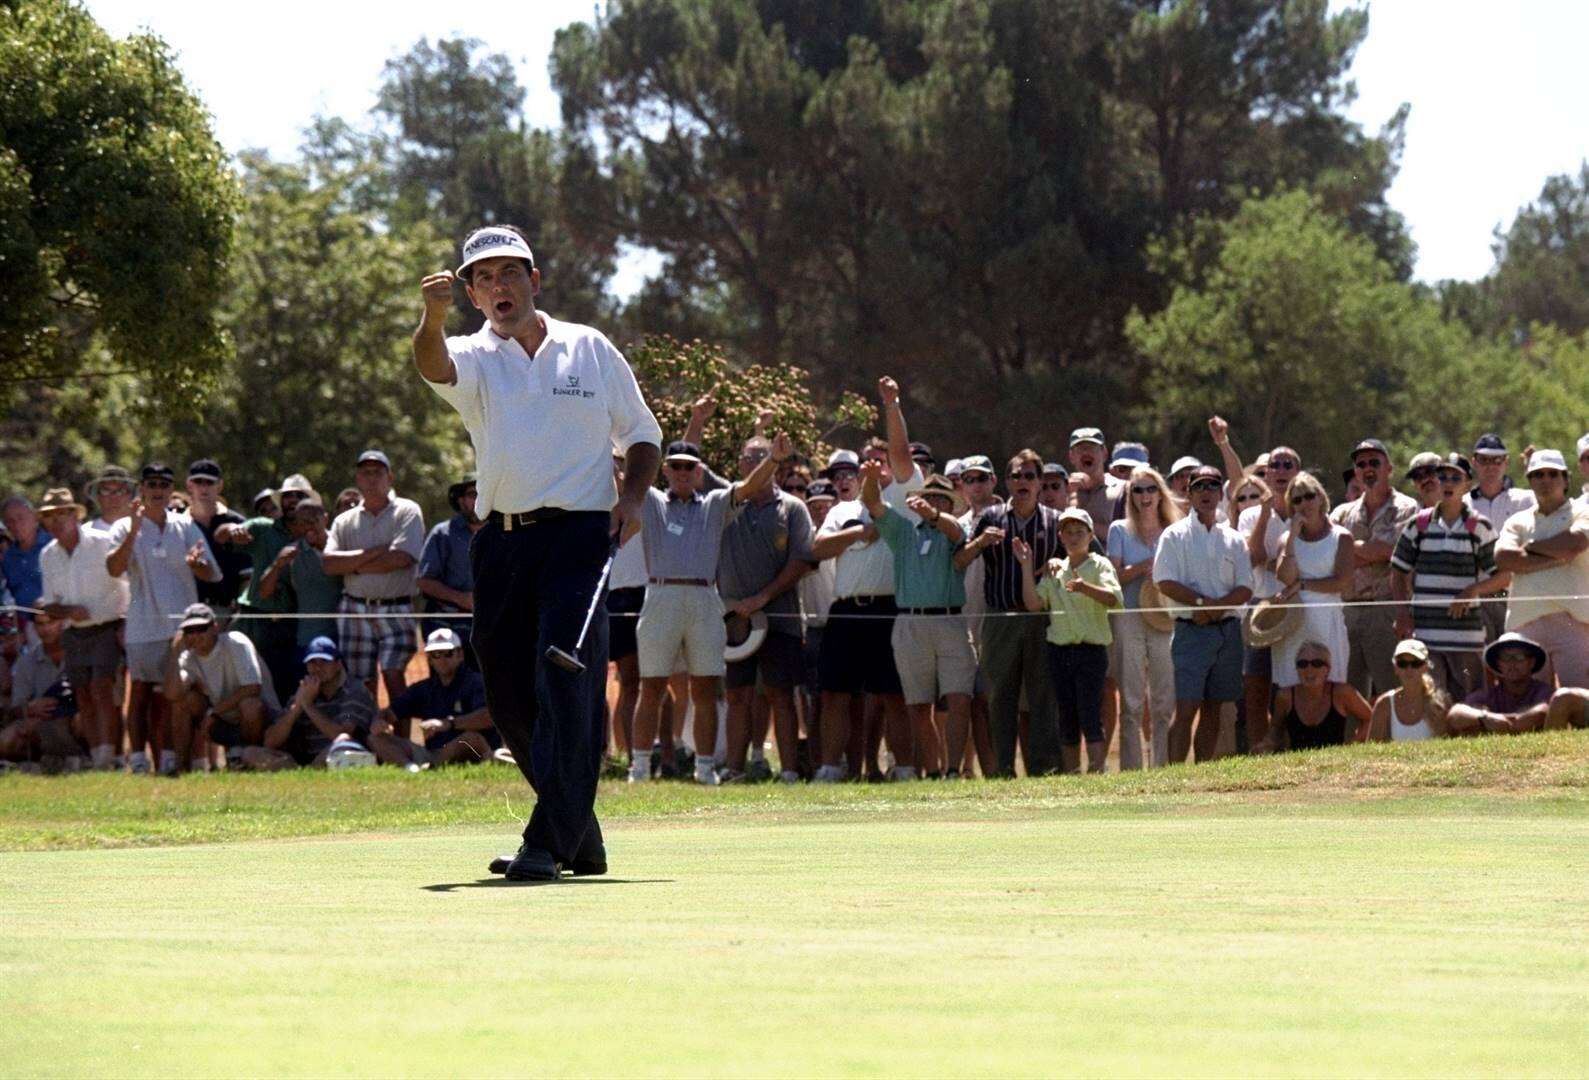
xmin=1012 ymin=507 xmax=1123 ymax=772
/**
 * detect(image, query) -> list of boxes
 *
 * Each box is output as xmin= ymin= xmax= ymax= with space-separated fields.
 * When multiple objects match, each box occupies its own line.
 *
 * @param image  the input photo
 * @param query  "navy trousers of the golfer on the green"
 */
xmin=469 ymin=513 xmax=610 ymax=862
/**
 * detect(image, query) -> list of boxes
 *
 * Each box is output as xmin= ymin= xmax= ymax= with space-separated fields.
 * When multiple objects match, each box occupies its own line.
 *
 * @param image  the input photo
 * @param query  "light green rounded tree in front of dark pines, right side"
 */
xmin=1127 ymin=191 xmax=1461 ymax=476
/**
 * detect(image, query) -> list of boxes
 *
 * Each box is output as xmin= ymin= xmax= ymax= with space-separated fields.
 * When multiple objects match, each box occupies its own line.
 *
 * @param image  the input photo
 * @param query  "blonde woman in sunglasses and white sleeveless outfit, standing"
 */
xmin=1274 ymin=472 xmax=1352 ymax=692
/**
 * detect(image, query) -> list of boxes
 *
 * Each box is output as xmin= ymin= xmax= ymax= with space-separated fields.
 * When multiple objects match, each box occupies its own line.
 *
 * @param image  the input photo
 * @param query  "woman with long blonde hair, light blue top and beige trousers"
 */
xmin=1109 ymin=465 xmax=1181 ymax=770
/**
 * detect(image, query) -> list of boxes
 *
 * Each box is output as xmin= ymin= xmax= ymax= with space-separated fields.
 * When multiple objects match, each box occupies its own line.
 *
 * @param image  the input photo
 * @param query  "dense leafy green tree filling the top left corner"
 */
xmin=0 ymin=0 xmax=237 ymax=402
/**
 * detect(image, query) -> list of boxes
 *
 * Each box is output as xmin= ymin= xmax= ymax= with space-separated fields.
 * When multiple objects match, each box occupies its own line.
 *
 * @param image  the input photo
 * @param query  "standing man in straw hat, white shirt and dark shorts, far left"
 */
xmin=38 ymin=488 xmax=127 ymax=769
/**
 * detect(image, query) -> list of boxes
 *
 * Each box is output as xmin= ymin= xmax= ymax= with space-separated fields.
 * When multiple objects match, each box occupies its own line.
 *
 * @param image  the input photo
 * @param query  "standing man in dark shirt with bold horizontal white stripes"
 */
xmin=1390 ymin=453 xmax=1506 ymax=700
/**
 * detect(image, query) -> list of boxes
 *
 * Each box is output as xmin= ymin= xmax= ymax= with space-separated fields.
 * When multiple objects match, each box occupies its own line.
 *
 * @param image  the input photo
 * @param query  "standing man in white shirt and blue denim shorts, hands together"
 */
xmin=1154 ymin=465 xmax=1252 ymax=762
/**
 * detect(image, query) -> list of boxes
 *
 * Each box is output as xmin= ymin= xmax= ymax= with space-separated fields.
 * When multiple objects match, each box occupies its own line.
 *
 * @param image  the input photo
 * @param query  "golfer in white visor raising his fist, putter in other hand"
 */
xmin=413 ymin=226 xmax=663 ymax=881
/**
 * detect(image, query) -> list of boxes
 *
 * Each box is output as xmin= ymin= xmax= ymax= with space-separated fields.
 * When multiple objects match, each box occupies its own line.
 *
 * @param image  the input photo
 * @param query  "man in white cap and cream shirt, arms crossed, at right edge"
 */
xmin=1495 ymin=449 xmax=1589 ymax=688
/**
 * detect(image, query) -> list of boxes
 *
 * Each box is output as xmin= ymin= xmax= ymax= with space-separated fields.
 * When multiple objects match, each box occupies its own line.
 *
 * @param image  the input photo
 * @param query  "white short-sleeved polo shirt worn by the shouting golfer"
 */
xmin=431 ymin=313 xmax=663 ymax=518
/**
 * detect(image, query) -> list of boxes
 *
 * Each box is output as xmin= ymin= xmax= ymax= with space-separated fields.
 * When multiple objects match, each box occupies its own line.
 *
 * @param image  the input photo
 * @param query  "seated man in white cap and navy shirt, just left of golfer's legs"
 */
xmin=369 ymin=626 xmax=502 ymax=769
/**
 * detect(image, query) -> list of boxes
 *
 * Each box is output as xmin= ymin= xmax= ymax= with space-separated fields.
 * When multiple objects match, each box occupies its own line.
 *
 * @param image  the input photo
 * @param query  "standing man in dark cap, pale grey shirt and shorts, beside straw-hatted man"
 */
xmin=105 ymin=462 xmax=221 ymax=775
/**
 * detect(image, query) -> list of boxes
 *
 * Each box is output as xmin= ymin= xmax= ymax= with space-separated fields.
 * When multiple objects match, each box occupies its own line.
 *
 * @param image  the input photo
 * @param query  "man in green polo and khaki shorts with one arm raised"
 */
xmin=861 ymin=461 xmax=977 ymax=778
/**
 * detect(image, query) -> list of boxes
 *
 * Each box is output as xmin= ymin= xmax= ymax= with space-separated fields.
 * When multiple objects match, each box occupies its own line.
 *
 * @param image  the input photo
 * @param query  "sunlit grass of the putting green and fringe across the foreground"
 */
xmin=0 ymin=734 xmax=1589 ymax=1075
